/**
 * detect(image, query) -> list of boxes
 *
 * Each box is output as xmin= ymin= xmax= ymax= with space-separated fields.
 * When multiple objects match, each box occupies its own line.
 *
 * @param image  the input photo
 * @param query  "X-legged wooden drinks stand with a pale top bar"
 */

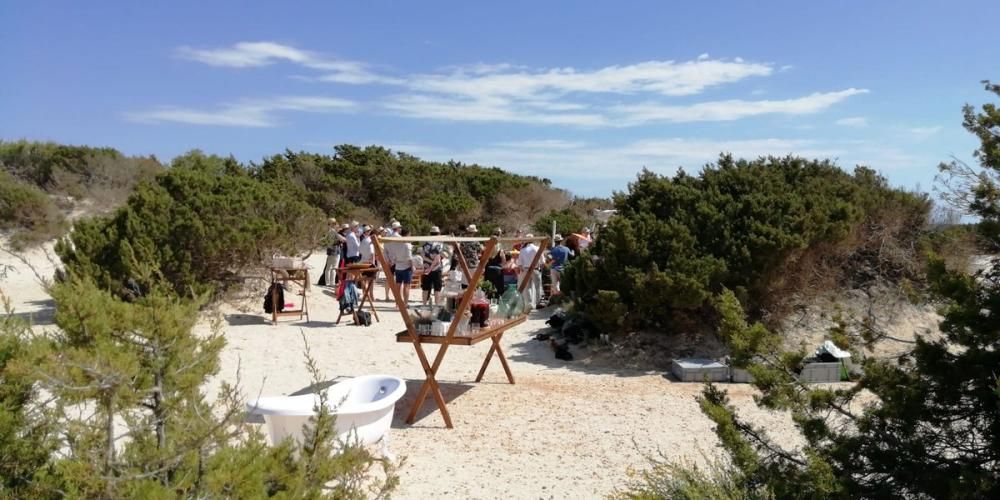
xmin=373 ymin=236 xmax=548 ymax=429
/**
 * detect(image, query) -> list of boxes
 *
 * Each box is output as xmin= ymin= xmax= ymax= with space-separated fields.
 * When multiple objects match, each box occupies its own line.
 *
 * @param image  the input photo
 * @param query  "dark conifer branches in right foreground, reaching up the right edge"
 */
xmin=616 ymin=82 xmax=1000 ymax=498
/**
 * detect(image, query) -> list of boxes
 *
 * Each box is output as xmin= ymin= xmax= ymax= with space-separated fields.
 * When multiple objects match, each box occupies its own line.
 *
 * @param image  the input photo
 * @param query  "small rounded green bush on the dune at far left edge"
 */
xmin=0 ymin=170 xmax=66 ymax=248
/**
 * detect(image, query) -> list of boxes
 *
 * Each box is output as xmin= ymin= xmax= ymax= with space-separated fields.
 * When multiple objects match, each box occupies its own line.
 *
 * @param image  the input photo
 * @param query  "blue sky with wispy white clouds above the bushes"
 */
xmin=0 ymin=0 xmax=1000 ymax=196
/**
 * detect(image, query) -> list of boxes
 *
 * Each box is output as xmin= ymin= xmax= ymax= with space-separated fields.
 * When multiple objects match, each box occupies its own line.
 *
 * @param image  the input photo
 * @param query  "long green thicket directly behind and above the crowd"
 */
xmin=250 ymin=145 xmax=563 ymax=233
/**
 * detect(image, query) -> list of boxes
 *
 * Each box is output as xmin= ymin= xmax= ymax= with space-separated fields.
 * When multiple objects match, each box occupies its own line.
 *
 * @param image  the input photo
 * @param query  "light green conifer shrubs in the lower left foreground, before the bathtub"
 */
xmin=0 ymin=274 xmax=398 ymax=498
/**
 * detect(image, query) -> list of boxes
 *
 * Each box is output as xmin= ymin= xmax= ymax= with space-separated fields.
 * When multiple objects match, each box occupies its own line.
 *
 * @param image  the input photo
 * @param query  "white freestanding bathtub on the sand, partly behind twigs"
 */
xmin=247 ymin=375 xmax=406 ymax=454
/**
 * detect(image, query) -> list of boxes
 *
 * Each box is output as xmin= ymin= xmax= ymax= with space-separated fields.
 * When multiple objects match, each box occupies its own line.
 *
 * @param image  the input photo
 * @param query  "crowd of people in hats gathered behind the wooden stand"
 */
xmin=318 ymin=218 xmax=593 ymax=305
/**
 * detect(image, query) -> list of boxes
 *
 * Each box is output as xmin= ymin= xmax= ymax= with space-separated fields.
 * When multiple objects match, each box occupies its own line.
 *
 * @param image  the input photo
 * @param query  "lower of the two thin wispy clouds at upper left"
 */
xmin=125 ymin=96 xmax=357 ymax=127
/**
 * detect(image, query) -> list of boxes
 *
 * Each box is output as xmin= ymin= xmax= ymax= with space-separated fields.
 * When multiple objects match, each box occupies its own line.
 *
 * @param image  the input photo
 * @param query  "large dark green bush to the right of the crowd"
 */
xmin=564 ymin=155 xmax=930 ymax=332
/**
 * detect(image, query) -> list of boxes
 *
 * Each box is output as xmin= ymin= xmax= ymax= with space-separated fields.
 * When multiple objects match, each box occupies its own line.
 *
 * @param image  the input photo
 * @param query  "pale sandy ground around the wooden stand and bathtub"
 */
xmin=7 ymin=250 xmax=916 ymax=498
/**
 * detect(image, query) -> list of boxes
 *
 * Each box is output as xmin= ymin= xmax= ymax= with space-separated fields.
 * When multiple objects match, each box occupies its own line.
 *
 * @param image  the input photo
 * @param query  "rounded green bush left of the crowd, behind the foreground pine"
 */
xmin=56 ymin=152 xmax=325 ymax=296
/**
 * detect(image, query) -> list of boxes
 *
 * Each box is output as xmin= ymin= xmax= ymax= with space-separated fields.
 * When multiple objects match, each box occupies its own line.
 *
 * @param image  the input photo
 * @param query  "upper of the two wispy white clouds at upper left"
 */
xmin=176 ymin=42 xmax=401 ymax=84
